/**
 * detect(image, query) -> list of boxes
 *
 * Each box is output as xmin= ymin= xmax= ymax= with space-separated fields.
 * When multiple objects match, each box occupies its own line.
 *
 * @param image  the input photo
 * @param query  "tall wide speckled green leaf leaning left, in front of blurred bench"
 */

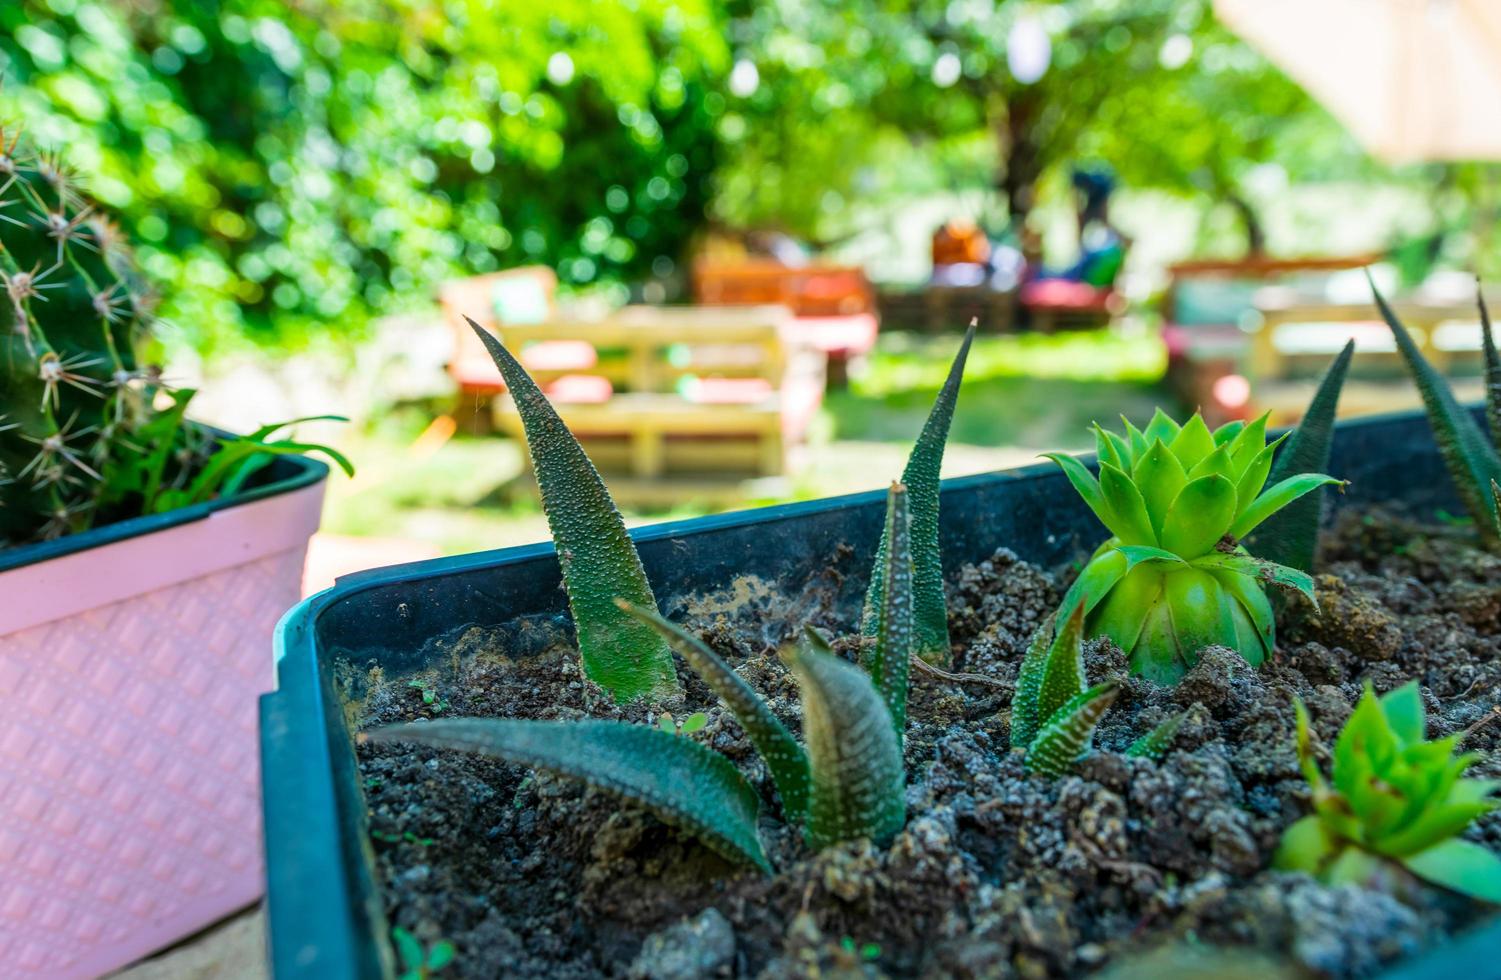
xmin=468 ymin=320 xmax=678 ymax=701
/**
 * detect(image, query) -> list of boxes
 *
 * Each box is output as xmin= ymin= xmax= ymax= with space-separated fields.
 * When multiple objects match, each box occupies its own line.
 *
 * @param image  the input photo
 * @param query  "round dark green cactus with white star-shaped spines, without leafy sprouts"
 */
xmin=0 ymin=128 xmax=158 ymax=543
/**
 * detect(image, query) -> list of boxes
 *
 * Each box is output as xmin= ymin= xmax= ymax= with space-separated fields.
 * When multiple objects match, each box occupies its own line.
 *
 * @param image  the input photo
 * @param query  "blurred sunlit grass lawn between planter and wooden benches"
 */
xmin=324 ymin=332 xmax=1165 ymax=554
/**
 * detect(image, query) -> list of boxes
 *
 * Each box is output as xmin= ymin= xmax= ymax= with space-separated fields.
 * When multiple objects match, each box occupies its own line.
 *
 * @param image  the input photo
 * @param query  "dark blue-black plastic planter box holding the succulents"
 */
xmin=261 ymin=413 xmax=1501 ymax=980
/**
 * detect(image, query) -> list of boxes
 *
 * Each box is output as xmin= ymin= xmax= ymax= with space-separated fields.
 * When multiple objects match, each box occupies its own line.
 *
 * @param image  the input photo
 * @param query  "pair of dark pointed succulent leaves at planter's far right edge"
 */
xmin=1366 ymin=279 xmax=1501 ymax=548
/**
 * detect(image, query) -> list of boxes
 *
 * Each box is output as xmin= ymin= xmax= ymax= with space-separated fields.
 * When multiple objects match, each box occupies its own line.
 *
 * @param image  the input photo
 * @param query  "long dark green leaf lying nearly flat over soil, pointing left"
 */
xmin=366 ymin=717 xmax=772 ymax=872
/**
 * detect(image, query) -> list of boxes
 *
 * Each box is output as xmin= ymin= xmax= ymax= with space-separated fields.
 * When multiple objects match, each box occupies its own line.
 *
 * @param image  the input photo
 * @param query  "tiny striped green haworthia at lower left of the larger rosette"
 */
xmin=1012 ymin=600 xmax=1120 ymax=777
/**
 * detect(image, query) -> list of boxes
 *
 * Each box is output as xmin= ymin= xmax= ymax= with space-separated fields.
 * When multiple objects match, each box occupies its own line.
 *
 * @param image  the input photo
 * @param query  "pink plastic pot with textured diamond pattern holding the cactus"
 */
xmin=0 ymin=480 xmax=323 ymax=980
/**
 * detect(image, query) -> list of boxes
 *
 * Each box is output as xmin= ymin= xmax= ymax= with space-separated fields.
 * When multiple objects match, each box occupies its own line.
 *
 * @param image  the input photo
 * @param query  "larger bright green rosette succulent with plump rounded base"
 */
xmin=1049 ymin=410 xmax=1339 ymax=683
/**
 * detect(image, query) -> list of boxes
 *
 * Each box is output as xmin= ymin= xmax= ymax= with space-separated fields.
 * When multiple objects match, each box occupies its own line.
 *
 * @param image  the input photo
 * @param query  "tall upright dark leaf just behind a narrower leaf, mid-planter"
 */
xmin=862 ymin=323 xmax=974 ymax=665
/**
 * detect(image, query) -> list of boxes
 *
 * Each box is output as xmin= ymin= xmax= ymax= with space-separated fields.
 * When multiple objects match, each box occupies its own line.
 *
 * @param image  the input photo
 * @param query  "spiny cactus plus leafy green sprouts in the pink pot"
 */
xmin=0 ymin=126 xmax=353 ymax=546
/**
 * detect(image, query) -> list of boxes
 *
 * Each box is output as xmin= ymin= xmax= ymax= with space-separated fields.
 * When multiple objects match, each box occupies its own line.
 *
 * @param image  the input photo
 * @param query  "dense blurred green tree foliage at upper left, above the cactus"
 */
xmin=0 ymin=0 xmax=726 ymax=349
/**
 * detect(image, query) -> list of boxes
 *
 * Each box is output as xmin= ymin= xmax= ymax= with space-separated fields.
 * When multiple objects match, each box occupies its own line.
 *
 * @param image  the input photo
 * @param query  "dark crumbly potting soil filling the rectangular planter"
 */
xmin=342 ymin=512 xmax=1501 ymax=980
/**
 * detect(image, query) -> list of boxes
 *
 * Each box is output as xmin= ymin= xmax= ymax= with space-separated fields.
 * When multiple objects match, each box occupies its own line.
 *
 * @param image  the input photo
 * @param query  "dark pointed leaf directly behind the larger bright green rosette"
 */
xmin=1246 ymin=341 xmax=1355 ymax=572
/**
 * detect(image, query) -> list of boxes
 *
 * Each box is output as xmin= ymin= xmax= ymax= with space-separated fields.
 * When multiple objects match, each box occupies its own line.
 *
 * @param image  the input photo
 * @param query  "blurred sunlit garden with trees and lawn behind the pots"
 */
xmin=11 ymin=0 xmax=1501 ymax=563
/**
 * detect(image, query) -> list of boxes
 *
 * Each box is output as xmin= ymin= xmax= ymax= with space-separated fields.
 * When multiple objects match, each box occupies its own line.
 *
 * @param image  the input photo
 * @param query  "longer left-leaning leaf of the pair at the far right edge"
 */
xmin=1367 ymin=273 xmax=1501 ymax=543
